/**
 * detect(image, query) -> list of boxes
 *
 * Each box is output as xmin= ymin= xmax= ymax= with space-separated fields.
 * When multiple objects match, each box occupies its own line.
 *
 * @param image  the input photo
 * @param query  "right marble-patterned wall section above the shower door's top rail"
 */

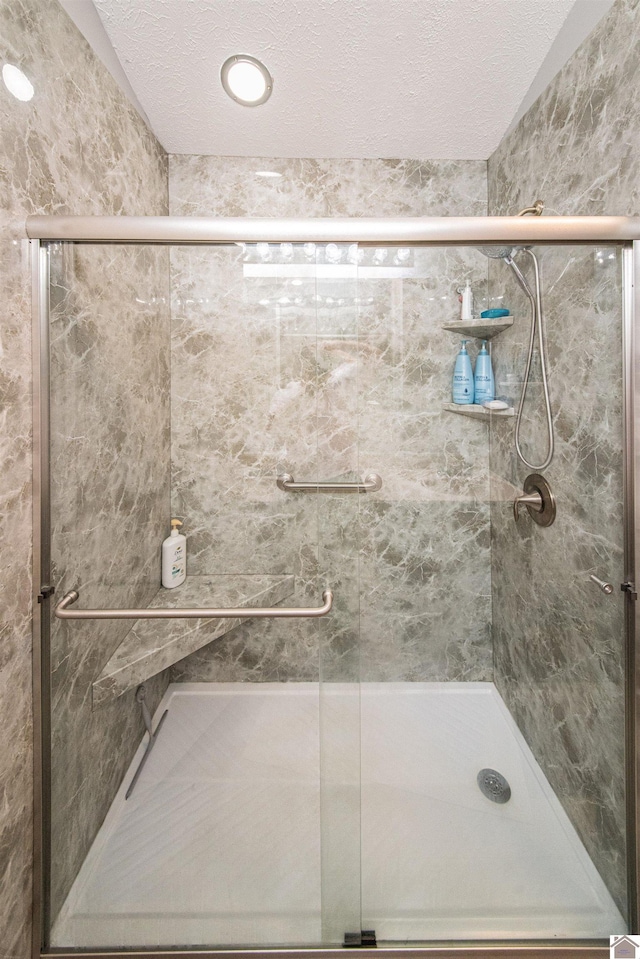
xmin=489 ymin=0 xmax=640 ymax=216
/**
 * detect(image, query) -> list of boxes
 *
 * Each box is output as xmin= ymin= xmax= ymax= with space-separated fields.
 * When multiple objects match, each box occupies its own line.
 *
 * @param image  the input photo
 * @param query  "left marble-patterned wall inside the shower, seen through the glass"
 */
xmin=51 ymin=238 xmax=170 ymax=914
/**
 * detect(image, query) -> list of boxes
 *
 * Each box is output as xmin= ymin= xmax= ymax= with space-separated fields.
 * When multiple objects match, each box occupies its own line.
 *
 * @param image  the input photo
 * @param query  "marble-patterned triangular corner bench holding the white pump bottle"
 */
xmin=93 ymin=573 xmax=295 ymax=708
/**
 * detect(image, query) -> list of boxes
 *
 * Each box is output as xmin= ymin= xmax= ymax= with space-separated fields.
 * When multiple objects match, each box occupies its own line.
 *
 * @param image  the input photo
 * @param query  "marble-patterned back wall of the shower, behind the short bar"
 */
xmin=169 ymin=156 xmax=492 ymax=681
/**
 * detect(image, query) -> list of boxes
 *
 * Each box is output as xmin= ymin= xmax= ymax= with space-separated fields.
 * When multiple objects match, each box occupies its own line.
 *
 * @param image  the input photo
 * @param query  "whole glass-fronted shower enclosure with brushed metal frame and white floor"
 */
xmin=28 ymin=217 xmax=640 ymax=956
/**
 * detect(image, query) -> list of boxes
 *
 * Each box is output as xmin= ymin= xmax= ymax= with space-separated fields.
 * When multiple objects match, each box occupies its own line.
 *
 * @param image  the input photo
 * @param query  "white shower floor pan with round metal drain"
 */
xmin=52 ymin=683 xmax=626 ymax=948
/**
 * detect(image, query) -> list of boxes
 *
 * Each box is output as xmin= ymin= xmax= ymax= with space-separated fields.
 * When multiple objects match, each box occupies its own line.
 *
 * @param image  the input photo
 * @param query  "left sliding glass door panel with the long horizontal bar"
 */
xmin=49 ymin=243 xmax=359 ymax=949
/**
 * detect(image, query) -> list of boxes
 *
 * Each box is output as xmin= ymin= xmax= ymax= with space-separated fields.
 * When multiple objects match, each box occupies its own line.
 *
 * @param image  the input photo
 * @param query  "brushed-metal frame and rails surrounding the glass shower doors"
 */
xmin=26 ymin=216 xmax=640 ymax=959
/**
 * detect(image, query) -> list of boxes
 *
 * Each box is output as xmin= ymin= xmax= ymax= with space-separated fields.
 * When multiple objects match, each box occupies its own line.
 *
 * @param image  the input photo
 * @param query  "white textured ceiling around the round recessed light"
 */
xmin=94 ymin=0 xmax=575 ymax=159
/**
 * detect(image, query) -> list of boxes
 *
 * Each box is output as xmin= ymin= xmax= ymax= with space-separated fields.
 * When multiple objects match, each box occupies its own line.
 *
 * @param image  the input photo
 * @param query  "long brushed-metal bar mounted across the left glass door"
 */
xmin=54 ymin=589 xmax=333 ymax=619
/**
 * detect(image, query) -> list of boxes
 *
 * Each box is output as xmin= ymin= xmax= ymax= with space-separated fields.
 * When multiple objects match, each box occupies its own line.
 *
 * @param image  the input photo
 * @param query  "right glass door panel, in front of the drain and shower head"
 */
xmin=358 ymin=247 xmax=626 ymax=942
